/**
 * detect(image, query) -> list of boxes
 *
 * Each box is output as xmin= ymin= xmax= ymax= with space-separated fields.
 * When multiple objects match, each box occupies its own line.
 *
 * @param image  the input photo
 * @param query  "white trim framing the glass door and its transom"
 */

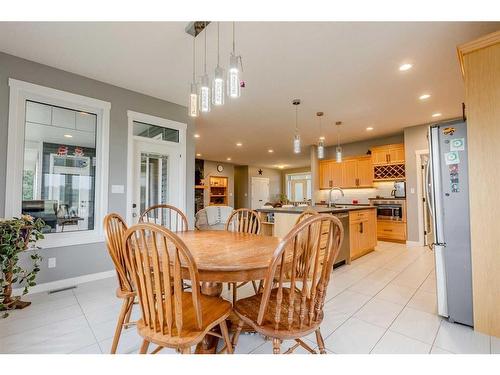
xmin=126 ymin=111 xmax=187 ymax=225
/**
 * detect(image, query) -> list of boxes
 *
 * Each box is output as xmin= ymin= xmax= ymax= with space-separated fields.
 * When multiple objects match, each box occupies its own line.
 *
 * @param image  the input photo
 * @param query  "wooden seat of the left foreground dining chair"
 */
xmin=137 ymin=292 xmax=232 ymax=348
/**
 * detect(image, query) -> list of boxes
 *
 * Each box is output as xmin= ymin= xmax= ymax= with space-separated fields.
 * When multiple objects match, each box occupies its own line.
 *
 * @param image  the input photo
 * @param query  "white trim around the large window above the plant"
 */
xmin=4 ymin=78 xmax=111 ymax=248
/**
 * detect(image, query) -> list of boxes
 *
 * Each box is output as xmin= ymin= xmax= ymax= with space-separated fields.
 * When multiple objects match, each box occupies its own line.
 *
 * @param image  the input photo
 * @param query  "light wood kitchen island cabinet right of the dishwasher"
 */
xmin=349 ymin=209 xmax=377 ymax=260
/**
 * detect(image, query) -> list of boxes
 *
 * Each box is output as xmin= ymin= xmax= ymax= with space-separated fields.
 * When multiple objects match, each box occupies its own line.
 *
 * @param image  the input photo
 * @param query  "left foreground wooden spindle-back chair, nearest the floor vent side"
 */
xmin=124 ymin=223 xmax=233 ymax=354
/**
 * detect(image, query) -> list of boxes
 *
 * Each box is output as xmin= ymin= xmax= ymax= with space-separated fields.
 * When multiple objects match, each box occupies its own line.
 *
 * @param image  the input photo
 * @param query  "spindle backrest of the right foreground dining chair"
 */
xmin=257 ymin=214 xmax=344 ymax=330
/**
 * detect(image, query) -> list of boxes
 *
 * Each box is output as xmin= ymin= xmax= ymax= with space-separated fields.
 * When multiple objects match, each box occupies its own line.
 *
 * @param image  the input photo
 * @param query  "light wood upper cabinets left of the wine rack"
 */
xmin=319 ymin=156 xmax=373 ymax=189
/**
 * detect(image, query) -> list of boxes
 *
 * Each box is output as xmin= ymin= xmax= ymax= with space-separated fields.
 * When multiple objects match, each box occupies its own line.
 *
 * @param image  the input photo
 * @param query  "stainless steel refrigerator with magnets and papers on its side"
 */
xmin=426 ymin=121 xmax=473 ymax=326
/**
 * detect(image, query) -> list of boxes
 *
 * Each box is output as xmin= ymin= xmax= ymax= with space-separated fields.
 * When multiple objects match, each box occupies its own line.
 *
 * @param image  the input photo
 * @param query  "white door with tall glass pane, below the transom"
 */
xmin=132 ymin=139 xmax=185 ymax=223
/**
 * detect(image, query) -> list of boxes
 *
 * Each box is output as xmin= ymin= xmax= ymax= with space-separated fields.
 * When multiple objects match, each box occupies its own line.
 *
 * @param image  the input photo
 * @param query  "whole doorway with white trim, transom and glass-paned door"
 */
xmin=127 ymin=111 xmax=186 ymax=224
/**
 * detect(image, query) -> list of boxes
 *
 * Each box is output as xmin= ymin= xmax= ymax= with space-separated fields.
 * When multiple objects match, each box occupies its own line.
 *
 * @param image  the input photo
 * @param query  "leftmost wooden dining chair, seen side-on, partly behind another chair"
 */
xmin=104 ymin=213 xmax=136 ymax=354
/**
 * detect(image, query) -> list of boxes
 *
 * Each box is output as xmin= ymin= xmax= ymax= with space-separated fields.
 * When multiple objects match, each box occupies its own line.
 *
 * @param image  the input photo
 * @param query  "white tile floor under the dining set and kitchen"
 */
xmin=0 ymin=242 xmax=500 ymax=354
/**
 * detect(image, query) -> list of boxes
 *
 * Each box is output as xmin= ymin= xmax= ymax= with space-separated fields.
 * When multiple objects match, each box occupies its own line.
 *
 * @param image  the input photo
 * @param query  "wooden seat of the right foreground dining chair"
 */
xmin=233 ymin=288 xmax=323 ymax=340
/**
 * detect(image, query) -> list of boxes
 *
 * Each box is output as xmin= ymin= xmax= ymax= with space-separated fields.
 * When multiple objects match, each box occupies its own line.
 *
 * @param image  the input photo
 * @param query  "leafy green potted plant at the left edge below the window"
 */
xmin=0 ymin=215 xmax=45 ymax=317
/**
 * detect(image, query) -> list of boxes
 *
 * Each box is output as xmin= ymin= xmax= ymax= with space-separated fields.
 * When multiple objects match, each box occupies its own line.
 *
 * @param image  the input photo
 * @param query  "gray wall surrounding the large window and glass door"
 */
xmin=0 ymin=53 xmax=194 ymax=283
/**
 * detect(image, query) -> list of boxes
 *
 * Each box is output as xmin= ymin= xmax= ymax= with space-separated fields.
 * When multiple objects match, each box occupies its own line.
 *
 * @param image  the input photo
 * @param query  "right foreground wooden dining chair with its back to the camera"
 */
xmin=233 ymin=215 xmax=344 ymax=354
